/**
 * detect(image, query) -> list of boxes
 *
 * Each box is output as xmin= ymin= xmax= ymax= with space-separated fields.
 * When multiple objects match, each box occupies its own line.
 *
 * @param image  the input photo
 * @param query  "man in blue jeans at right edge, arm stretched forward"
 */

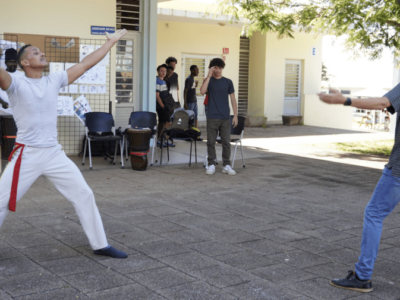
xmin=318 ymin=84 xmax=400 ymax=292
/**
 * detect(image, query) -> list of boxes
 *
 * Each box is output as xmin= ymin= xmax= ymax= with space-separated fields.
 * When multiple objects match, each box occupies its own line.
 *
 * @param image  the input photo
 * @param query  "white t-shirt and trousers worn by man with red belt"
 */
xmin=0 ymin=71 xmax=108 ymax=250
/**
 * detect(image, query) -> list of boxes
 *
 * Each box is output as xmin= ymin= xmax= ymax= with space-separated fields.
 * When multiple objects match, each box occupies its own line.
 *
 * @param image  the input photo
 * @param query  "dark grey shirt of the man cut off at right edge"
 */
xmin=384 ymin=83 xmax=400 ymax=177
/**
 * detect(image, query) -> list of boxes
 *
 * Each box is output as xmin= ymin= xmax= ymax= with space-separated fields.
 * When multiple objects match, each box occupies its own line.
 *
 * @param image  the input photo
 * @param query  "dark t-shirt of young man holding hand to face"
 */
xmin=207 ymin=77 xmax=235 ymax=120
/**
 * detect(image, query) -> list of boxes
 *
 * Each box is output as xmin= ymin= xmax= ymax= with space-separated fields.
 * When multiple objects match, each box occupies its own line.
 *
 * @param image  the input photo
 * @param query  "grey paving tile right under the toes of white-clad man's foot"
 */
xmin=100 ymin=254 xmax=165 ymax=274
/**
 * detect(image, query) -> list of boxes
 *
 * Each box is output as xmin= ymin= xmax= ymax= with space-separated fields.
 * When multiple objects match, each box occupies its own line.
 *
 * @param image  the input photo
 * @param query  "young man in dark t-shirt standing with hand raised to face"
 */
xmin=200 ymin=58 xmax=238 ymax=175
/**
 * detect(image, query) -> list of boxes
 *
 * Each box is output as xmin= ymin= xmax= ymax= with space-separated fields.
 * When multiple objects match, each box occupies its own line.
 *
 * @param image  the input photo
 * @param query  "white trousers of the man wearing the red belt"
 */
xmin=0 ymin=145 xmax=108 ymax=250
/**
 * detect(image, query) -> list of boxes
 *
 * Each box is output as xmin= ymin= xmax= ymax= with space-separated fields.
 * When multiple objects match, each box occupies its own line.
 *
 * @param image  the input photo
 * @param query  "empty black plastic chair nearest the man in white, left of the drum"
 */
xmin=82 ymin=112 xmax=124 ymax=169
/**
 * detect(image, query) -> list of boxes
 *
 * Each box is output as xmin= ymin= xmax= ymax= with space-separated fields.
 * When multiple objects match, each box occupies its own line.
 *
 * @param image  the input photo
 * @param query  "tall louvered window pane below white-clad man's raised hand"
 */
xmin=115 ymin=40 xmax=133 ymax=103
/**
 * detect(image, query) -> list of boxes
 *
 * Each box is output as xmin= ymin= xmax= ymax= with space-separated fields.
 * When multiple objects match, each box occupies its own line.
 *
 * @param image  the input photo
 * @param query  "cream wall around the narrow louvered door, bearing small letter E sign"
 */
xmin=249 ymin=33 xmax=322 ymax=121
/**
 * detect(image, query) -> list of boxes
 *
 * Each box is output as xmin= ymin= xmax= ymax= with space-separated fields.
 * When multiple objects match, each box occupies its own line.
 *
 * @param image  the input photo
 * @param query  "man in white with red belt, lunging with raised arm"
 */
xmin=0 ymin=29 xmax=127 ymax=258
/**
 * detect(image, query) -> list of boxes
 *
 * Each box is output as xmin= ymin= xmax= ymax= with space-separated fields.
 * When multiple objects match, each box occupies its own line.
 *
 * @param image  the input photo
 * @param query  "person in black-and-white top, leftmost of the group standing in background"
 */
xmin=156 ymin=64 xmax=175 ymax=147
